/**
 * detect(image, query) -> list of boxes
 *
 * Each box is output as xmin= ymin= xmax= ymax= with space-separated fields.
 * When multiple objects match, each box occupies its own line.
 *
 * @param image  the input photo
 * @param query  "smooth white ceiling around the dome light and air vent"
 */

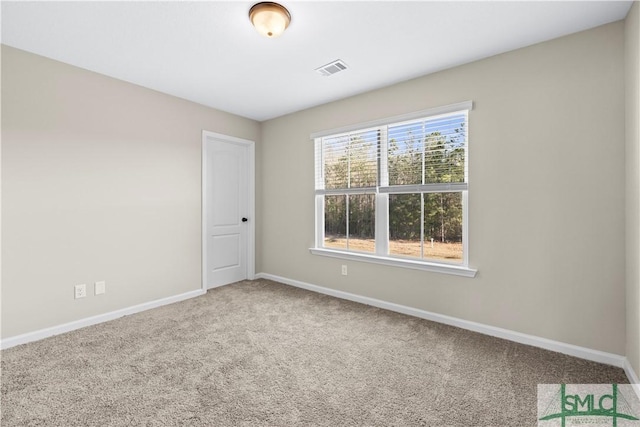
xmin=1 ymin=0 xmax=632 ymax=121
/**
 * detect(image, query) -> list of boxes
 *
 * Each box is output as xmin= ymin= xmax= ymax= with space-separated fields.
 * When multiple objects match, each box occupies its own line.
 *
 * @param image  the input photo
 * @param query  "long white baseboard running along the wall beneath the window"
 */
xmin=256 ymin=273 xmax=637 ymax=372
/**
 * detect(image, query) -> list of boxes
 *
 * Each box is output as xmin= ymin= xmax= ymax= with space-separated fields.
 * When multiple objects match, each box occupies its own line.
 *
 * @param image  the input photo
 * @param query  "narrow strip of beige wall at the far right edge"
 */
xmin=625 ymin=2 xmax=640 ymax=375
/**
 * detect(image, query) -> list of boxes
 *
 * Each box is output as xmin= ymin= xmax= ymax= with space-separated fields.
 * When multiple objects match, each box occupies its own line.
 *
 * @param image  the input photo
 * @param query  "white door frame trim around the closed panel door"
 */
xmin=201 ymin=130 xmax=256 ymax=291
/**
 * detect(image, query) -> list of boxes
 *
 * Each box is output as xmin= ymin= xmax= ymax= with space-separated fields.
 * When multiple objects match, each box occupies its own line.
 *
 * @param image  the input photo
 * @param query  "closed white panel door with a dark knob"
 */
xmin=203 ymin=132 xmax=253 ymax=289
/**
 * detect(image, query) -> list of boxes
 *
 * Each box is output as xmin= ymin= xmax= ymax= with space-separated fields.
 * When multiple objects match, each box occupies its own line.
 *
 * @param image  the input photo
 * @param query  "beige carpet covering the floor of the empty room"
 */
xmin=1 ymin=280 xmax=628 ymax=427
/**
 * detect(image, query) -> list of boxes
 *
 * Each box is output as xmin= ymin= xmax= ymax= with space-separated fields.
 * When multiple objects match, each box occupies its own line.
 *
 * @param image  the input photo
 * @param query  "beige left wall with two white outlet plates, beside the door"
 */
xmin=2 ymin=46 xmax=260 ymax=338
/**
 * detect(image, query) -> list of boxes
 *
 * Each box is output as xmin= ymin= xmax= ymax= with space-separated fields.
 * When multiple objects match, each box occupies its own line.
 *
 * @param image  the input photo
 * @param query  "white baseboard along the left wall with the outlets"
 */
xmin=0 ymin=289 xmax=206 ymax=350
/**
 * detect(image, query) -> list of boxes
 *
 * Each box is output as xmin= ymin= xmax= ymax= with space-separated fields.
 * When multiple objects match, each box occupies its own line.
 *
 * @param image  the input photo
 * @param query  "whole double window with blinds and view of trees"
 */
xmin=312 ymin=102 xmax=475 ymax=276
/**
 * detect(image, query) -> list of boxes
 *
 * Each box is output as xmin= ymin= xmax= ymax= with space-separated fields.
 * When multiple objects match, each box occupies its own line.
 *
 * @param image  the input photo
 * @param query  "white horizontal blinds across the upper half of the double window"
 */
xmin=315 ymin=103 xmax=470 ymax=194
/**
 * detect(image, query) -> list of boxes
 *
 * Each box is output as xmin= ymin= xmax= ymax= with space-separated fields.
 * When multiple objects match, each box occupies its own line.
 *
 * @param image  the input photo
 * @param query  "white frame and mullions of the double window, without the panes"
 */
xmin=309 ymin=101 xmax=477 ymax=277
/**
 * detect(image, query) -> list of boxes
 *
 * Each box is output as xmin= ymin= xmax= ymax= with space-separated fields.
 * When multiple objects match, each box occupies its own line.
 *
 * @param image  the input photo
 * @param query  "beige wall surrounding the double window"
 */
xmin=257 ymin=22 xmax=626 ymax=354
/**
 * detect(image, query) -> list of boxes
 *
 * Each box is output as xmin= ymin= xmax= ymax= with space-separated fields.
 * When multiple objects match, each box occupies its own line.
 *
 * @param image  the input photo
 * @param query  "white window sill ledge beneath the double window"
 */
xmin=309 ymin=248 xmax=478 ymax=277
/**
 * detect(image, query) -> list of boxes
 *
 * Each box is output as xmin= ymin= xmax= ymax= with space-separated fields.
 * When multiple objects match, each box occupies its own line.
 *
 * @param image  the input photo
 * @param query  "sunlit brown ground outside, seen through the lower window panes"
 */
xmin=324 ymin=237 xmax=462 ymax=261
